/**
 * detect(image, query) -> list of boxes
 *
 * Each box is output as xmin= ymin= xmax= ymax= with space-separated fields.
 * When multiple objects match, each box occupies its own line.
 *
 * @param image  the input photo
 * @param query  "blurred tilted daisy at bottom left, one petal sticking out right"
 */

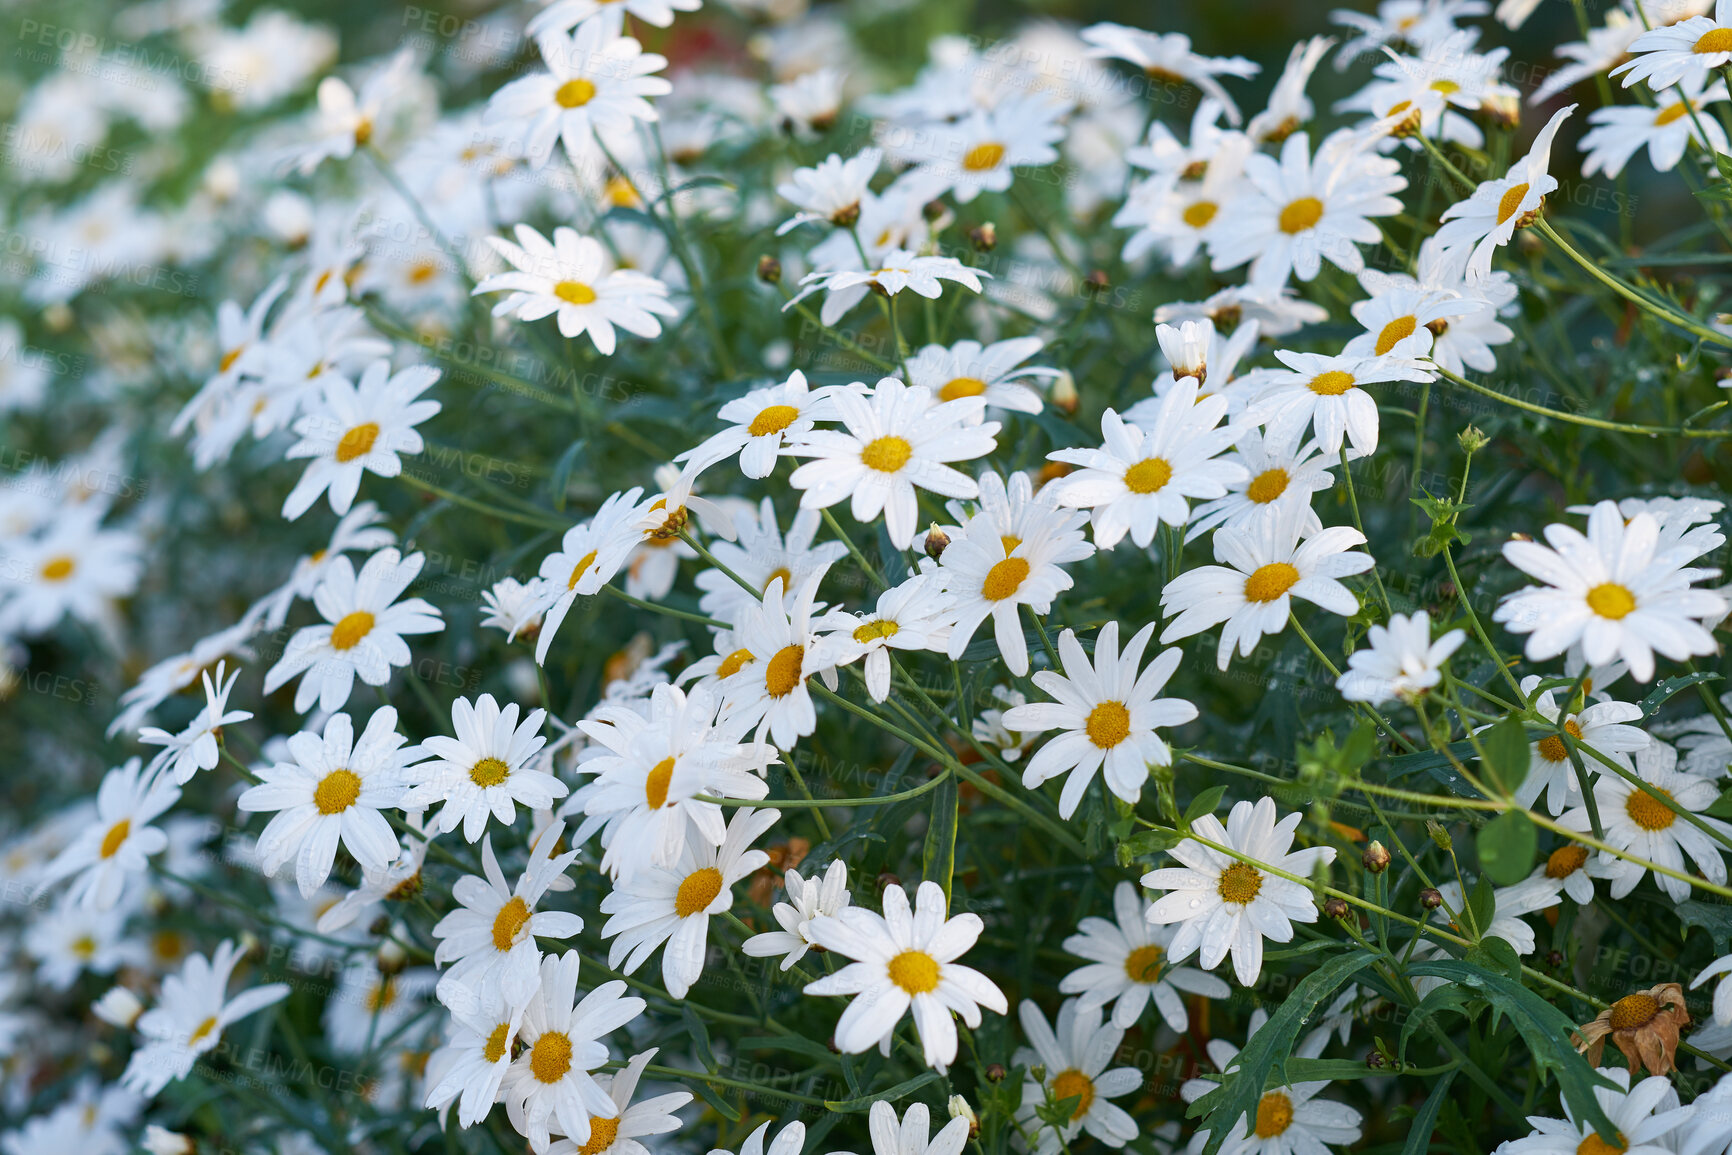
xmin=120 ymin=940 xmax=289 ymax=1098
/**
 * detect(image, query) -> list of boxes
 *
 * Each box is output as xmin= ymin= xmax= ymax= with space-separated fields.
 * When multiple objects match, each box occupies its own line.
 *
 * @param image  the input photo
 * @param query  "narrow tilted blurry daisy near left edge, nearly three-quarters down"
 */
xmin=36 ymin=758 xmax=180 ymax=911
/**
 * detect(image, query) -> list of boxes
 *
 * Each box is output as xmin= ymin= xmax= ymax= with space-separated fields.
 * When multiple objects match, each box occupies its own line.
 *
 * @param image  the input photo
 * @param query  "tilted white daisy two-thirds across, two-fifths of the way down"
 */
xmin=1048 ymin=377 xmax=1251 ymax=549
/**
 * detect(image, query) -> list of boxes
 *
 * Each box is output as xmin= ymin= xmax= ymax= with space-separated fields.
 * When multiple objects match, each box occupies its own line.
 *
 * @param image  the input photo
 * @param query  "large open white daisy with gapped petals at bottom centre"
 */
xmin=805 ymin=881 xmax=1010 ymax=1072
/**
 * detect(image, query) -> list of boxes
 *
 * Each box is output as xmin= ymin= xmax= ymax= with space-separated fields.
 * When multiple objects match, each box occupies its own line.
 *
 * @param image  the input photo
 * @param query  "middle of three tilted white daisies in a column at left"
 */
xmin=265 ymin=549 xmax=445 ymax=713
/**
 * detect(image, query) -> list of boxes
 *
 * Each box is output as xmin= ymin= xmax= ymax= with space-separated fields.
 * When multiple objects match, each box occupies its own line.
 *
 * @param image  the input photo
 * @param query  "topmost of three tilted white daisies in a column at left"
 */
xmin=282 ymin=360 xmax=440 ymax=521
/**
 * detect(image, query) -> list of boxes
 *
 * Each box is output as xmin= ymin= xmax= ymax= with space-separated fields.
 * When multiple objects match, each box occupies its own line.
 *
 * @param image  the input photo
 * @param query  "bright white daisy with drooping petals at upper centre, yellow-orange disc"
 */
xmin=788 ymin=377 xmax=999 ymax=549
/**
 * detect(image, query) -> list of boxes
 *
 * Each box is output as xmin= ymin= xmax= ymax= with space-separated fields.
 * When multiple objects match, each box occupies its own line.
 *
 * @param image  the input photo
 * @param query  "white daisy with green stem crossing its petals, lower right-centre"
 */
xmin=1143 ymin=798 xmax=1335 ymax=987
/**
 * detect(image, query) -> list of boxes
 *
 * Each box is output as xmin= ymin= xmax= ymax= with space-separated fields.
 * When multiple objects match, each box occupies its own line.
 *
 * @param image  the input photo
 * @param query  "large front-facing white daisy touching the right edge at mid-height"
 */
xmin=1491 ymin=500 xmax=1727 ymax=682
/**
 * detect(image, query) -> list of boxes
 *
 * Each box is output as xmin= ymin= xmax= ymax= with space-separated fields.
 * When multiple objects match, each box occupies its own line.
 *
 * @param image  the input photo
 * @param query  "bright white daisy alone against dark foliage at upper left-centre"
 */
xmin=475 ymin=225 xmax=679 ymax=355
